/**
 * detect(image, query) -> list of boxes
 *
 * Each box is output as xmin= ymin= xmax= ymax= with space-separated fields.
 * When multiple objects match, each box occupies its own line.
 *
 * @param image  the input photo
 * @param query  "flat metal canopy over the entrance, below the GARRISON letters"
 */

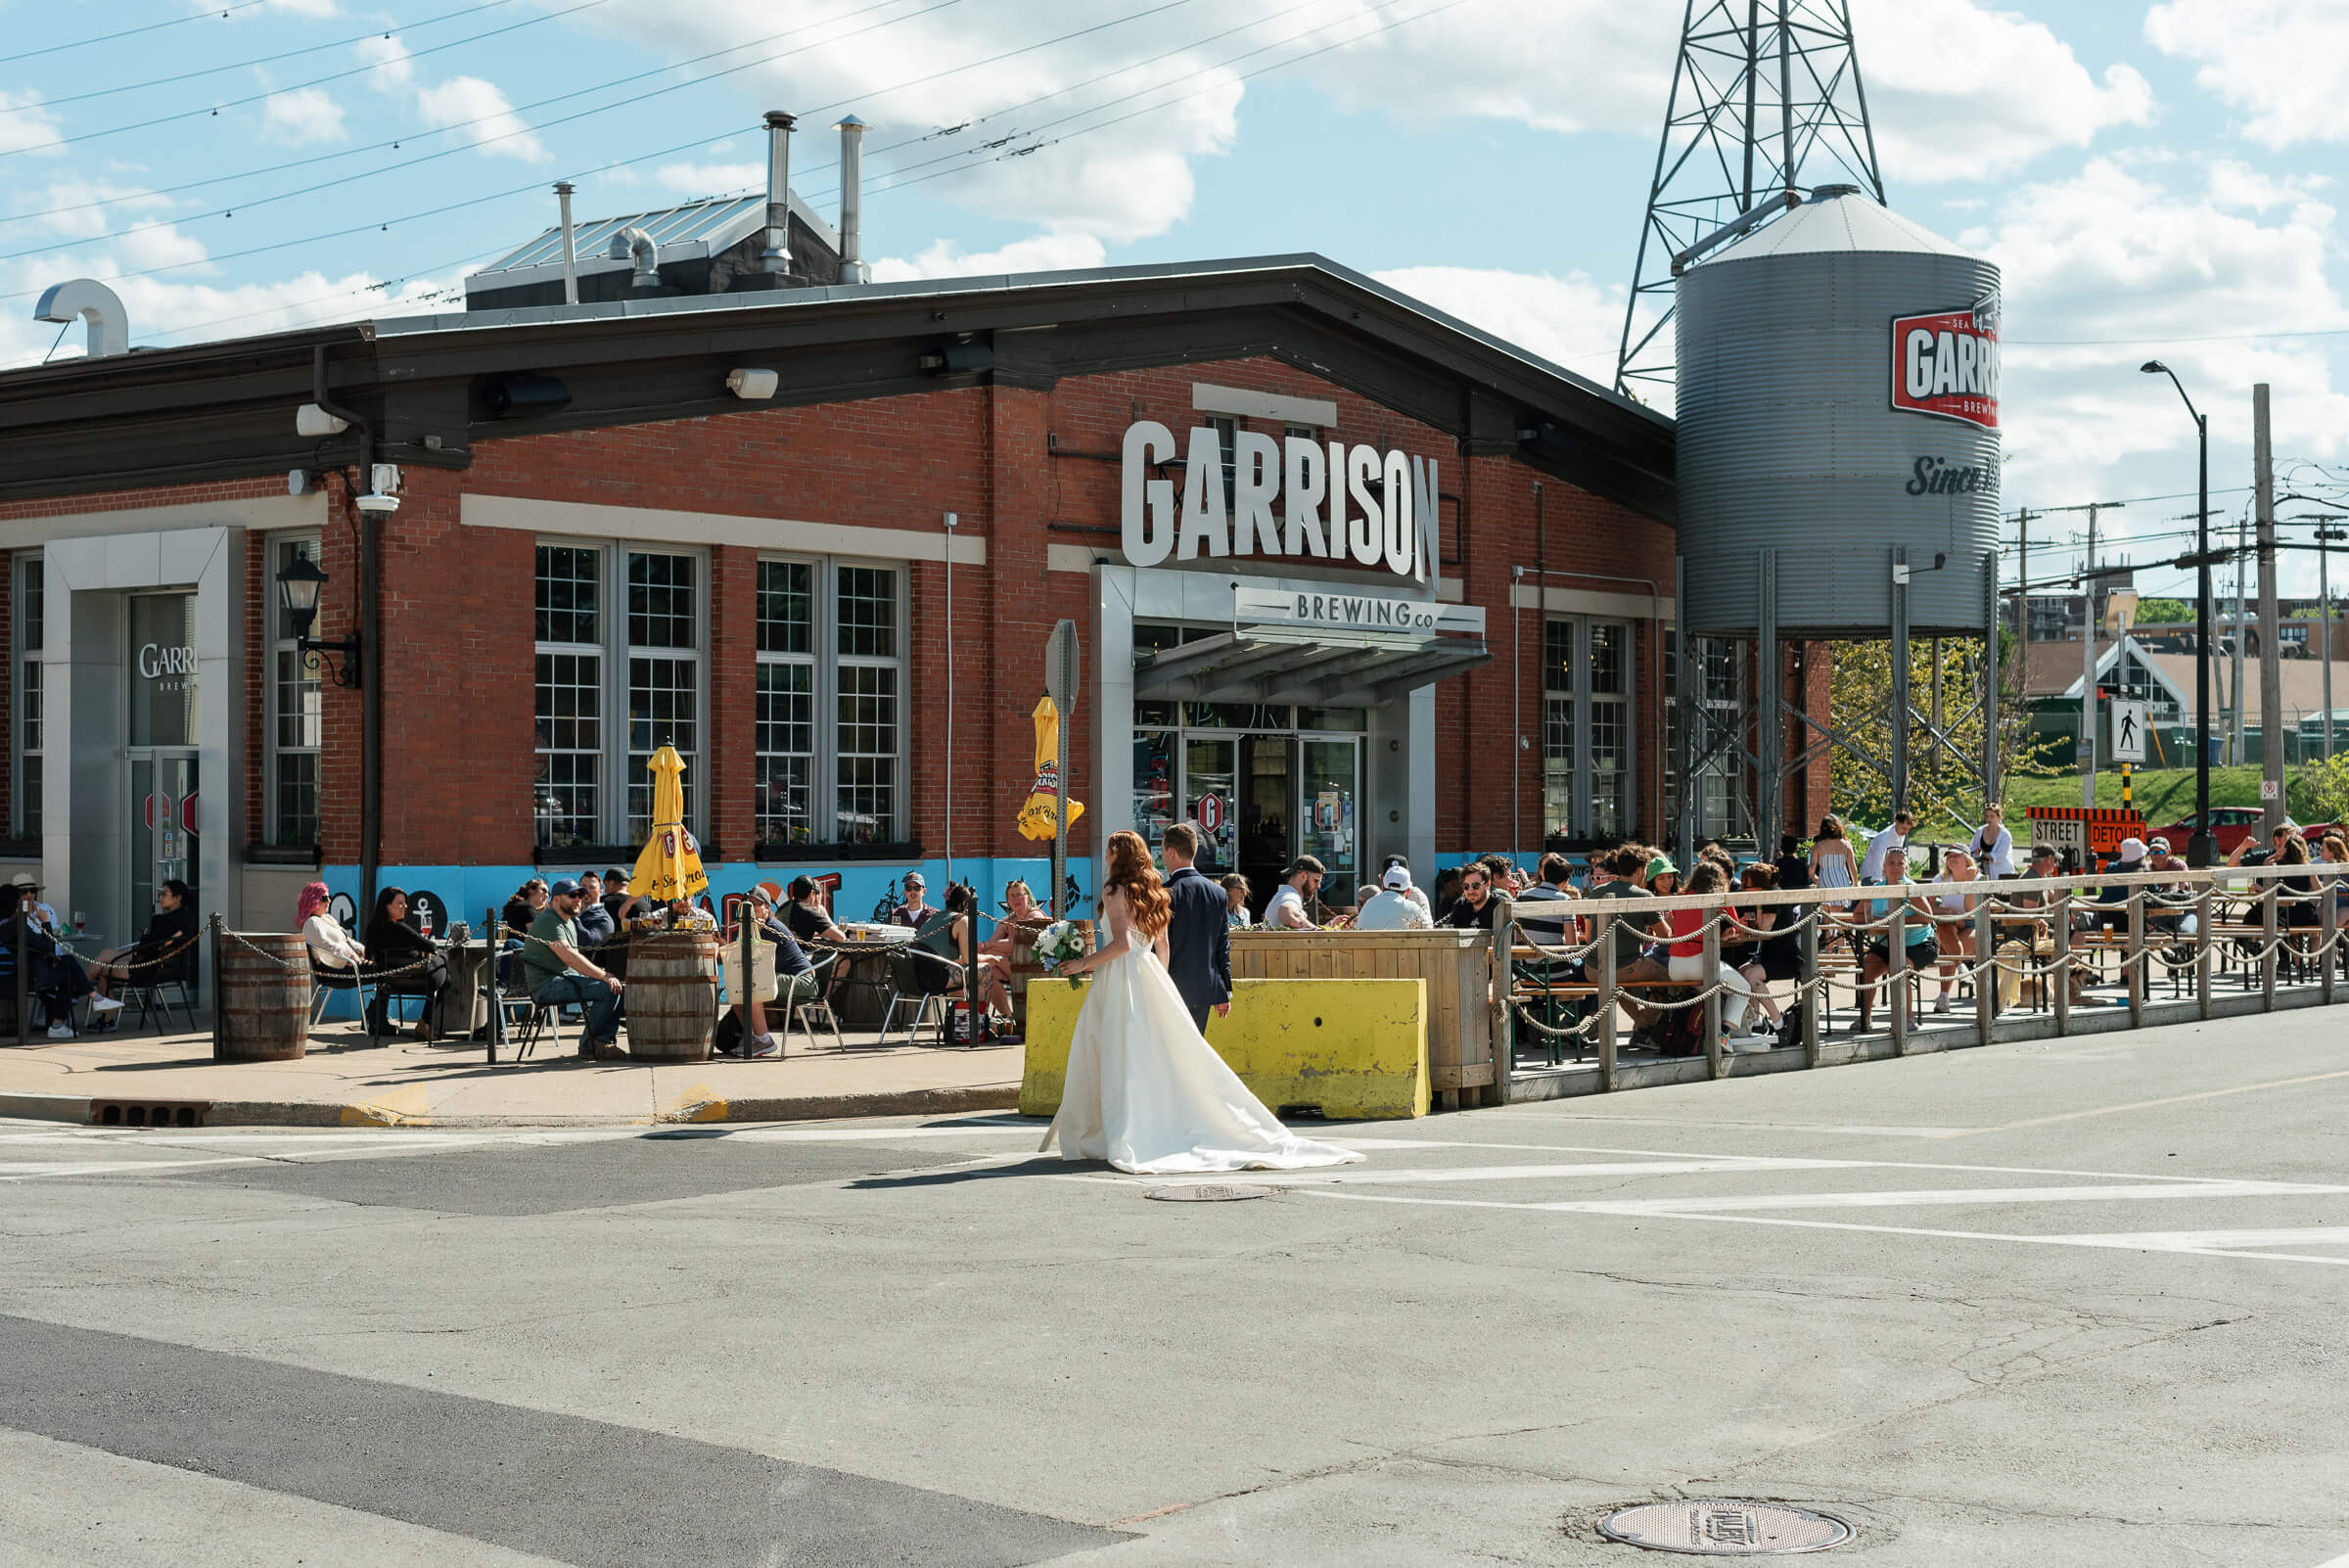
xmin=1134 ymin=626 xmax=1492 ymax=707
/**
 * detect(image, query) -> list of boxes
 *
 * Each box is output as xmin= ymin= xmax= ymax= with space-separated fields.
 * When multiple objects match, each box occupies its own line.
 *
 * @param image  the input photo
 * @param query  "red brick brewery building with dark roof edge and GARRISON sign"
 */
xmin=0 ymin=255 xmax=1673 ymax=957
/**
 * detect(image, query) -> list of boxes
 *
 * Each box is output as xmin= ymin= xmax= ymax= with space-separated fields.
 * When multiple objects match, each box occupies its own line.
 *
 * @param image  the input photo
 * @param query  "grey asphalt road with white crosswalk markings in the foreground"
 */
xmin=0 ymin=1012 xmax=2349 ymax=1568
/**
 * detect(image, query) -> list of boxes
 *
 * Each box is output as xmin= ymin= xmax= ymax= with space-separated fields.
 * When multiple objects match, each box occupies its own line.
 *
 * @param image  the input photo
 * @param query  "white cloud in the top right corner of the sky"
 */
xmin=2144 ymin=0 xmax=2349 ymax=148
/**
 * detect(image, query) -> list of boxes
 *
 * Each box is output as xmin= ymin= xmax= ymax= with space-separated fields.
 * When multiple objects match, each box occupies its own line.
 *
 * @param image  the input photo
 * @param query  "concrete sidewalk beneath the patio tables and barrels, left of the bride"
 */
xmin=0 ymin=1024 xmax=1022 ymax=1127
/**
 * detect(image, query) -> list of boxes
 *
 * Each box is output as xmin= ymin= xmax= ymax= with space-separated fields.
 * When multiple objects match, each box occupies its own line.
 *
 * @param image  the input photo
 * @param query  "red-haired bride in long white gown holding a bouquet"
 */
xmin=1032 ymin=833 xmax=1362 ymax=1176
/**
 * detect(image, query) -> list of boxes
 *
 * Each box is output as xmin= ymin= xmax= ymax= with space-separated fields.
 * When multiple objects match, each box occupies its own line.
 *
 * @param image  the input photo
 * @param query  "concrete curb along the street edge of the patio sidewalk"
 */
xmin=0 ymin=1084 xmax=1020 ymax=1130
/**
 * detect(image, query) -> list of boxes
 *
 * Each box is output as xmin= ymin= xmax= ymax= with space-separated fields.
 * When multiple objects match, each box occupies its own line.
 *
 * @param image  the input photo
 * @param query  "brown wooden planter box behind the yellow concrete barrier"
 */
xmin=1231 ymin=930 xmax=1492 ymax=1110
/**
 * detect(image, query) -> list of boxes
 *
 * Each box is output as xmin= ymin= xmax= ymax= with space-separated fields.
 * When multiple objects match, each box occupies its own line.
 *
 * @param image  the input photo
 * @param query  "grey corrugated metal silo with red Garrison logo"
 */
xmin=1678 ymin=185 xmax=1999 ymax=638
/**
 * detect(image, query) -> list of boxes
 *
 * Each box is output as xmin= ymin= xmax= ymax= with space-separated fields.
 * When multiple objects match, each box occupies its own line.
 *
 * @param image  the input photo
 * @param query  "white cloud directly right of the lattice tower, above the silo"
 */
xmin=1851 ymin=0 xmax=2154 ymax=188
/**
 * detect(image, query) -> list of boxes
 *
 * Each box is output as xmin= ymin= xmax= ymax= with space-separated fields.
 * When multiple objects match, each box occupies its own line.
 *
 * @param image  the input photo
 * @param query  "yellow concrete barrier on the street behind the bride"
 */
xmin=1020 ymin=979 xmax=1428 ymax=1120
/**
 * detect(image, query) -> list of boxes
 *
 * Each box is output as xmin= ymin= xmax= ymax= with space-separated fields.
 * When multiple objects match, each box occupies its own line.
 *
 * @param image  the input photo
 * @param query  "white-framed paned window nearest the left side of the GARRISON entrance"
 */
xmin=754 ymin=561 xmax=906 ymax=845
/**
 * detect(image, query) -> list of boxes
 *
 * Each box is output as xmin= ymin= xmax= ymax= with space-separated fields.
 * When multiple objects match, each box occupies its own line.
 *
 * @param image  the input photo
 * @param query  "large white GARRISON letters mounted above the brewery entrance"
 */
xmin=1118 ymin=420 xmax=1443 ymax=582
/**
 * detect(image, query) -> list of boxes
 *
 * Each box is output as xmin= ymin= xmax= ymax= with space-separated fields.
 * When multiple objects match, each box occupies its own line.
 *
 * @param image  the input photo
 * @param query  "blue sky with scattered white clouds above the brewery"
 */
xmin=0 ymin=0 xmax=2349 ymax=591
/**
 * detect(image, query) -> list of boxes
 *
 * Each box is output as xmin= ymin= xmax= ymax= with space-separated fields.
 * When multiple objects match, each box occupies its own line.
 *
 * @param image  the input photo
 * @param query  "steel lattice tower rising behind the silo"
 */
xmin=1616 ymin=0 xmax=1884 ymax=401
